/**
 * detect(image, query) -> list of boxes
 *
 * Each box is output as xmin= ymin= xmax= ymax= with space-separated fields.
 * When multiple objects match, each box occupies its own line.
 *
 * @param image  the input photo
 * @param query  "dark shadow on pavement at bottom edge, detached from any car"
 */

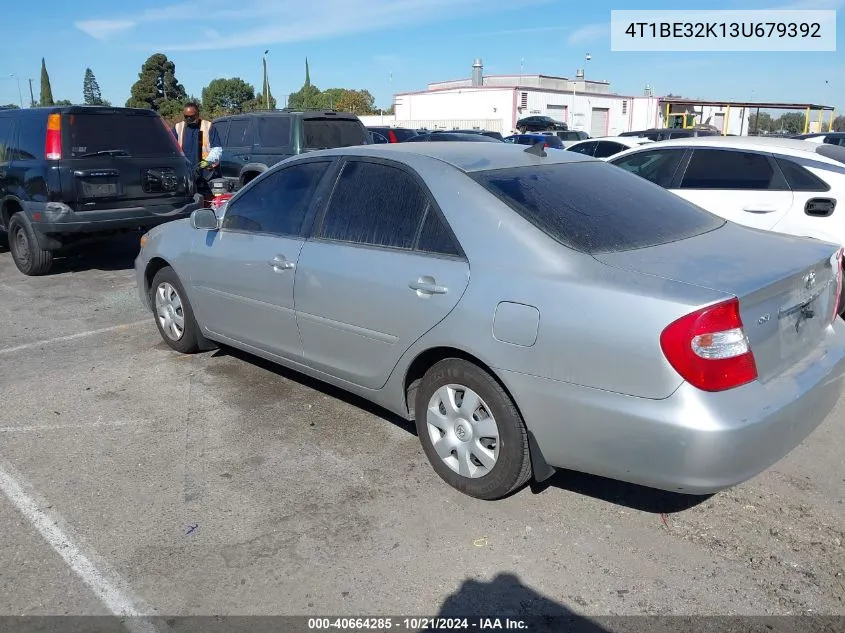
xmin=437 ymin=573 xmax=607 ymax=633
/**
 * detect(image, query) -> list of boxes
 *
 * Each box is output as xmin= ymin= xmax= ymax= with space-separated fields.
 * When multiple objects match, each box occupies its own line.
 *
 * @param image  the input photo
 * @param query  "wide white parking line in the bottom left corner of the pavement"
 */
xmin=0 ymin=466 xmax=161 ymax=633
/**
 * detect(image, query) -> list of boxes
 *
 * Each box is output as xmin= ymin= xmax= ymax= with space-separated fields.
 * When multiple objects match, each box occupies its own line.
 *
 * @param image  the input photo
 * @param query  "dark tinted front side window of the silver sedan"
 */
xmin=222 ymin=161 xmax=331 ymax=237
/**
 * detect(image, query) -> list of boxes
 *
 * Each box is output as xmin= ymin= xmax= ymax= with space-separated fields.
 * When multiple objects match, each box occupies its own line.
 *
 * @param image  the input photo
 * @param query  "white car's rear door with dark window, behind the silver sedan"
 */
xmin=671 ymin=148 xmax=793 ymax=230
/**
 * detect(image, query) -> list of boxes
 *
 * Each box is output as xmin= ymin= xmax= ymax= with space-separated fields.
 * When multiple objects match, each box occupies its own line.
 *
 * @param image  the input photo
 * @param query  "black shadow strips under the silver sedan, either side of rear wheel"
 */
xmin=212 ymin=345 xmax=712 ymax=514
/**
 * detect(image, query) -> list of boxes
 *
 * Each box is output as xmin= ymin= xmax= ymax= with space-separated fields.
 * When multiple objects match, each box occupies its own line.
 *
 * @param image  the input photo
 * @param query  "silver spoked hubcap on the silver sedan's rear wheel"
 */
xmin=426 ymin=384 xmax=499 ymax=479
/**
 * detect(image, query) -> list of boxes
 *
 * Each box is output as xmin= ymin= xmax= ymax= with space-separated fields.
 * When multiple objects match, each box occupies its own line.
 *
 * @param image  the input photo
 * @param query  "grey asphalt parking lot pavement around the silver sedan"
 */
xmin=0 ymin=236 xmax=845 ymax=616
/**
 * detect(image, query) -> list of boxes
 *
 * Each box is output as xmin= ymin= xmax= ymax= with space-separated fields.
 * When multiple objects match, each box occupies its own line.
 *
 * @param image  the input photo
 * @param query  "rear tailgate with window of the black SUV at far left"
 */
xmin=61 ymin=108 xmax=193 ymax=212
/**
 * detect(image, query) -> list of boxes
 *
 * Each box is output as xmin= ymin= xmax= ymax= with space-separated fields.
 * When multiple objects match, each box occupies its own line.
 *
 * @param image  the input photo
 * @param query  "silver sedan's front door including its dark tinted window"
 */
xmin=191 ymin=160 xmax=331 ymax=359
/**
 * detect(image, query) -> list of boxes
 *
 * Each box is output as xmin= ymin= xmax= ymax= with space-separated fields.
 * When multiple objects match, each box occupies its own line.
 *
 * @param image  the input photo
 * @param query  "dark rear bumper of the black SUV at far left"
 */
xmin=27 ymin=194 xmax=203 ymax=248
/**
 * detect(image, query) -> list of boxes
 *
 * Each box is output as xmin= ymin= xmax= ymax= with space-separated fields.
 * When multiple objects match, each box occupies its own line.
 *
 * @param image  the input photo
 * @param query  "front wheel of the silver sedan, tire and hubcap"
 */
xmin=150 ymin=266 xmax=201 ymax=354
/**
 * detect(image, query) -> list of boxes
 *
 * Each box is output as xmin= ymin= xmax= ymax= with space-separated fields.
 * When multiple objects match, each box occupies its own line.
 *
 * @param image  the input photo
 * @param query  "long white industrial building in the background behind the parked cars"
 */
xmin=362 ymin=59 xmax=830 ymax=136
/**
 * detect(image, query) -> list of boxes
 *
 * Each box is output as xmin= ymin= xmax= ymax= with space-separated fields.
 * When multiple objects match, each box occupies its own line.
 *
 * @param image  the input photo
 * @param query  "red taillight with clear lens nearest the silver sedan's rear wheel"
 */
xmin=660 ymin=298 xmax=757 ymax=391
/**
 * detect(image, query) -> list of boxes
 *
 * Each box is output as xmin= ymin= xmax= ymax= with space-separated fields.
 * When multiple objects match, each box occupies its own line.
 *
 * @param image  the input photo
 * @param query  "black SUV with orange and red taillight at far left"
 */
xmin=0 ymin=106 xmax=202 ymax=275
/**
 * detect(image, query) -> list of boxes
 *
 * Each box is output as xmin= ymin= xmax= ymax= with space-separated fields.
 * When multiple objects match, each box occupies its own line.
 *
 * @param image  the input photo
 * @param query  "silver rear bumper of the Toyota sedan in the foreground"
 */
xmin=500 ymin=320 xmax=845 ymax=494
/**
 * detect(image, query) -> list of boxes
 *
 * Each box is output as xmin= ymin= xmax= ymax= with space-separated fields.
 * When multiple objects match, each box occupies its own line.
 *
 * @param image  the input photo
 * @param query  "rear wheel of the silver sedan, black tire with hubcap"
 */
xmin=414 ymin=358 xmax=531 ymax=500
